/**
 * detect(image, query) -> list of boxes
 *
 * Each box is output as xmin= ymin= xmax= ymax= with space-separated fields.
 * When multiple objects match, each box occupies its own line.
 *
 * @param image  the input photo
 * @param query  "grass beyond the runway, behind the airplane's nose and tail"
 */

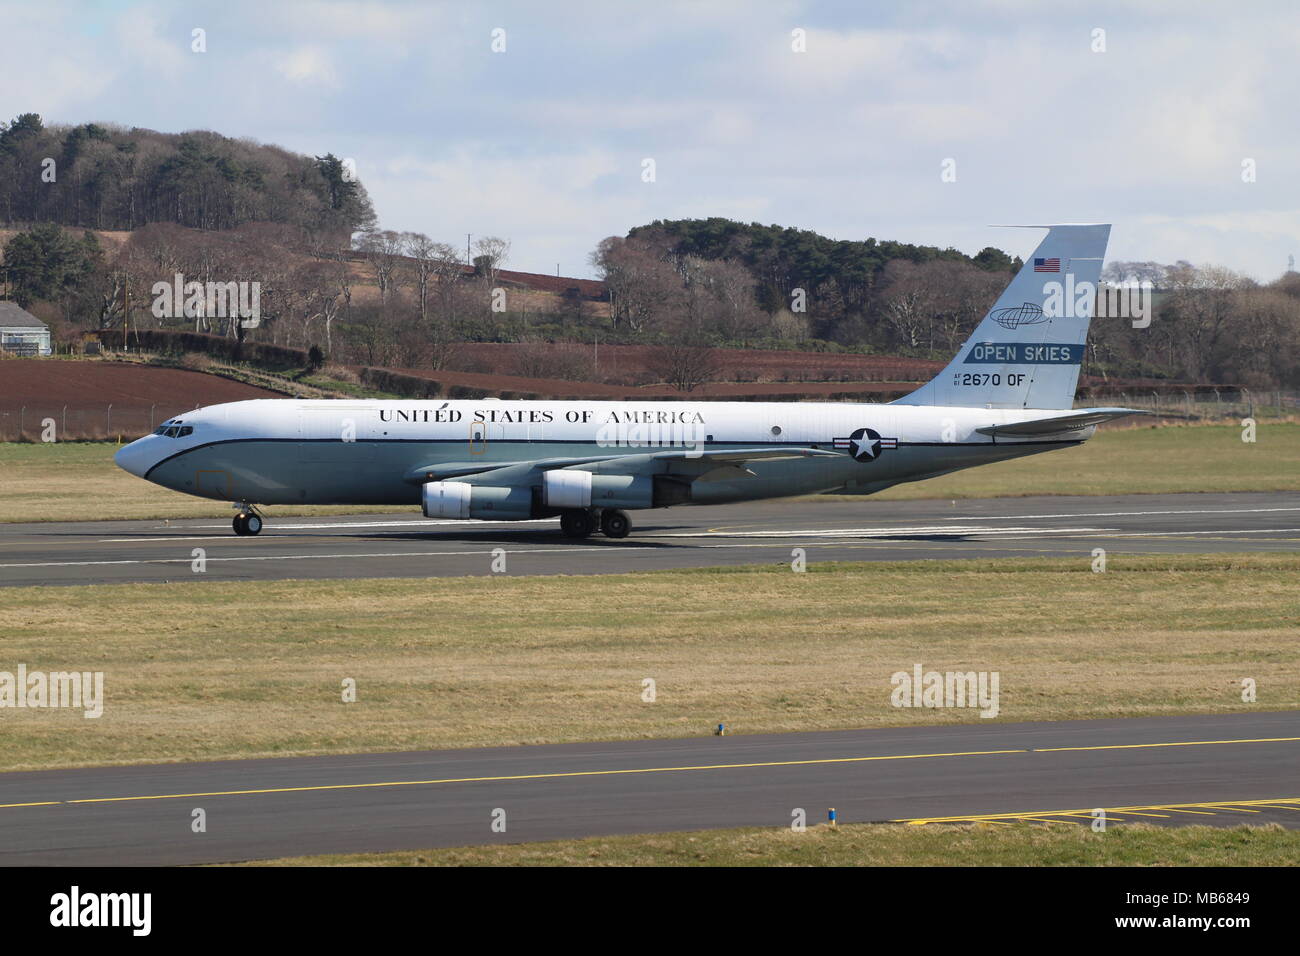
xmin=0 ymin=423 xmax=1300 ymax=522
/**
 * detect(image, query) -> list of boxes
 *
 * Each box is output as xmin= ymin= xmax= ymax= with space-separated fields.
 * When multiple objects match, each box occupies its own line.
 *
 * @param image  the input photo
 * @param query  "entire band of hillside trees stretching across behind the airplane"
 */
xmin=0 ymin=140 xmax=1300 ymax=388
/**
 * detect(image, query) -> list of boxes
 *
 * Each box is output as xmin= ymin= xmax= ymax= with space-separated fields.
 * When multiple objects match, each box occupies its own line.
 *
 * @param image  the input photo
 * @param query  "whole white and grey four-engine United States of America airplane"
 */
xmin=114 ymin=224 xmax=1145 ymax=538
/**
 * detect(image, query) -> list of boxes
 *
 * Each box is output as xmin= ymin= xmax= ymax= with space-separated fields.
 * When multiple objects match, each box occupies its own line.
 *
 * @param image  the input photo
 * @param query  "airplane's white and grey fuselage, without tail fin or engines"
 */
xmin=117 ymin=399 xmax=1093 ymax=505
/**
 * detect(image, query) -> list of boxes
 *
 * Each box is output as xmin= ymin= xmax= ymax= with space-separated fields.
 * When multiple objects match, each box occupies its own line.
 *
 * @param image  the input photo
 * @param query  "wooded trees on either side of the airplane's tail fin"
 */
xmin=592 ymin=219 xmax=1300 ymax=388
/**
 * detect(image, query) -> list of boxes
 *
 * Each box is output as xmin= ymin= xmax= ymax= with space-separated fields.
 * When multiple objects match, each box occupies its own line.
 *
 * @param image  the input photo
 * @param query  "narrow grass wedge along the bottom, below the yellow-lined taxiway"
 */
xmin=246 ymin=823 xmax=1300 ymax=866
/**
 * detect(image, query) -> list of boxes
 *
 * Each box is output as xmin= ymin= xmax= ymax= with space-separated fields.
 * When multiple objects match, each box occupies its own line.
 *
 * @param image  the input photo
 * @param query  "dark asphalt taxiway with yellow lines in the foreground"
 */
xmin=0 ymin=711 xmax=1300 ymax=865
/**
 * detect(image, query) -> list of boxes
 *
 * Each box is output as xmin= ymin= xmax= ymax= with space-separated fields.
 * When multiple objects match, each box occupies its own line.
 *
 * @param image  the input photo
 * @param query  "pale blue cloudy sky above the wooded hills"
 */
xmin=0 ymin=0 xmax=1300 ymax=281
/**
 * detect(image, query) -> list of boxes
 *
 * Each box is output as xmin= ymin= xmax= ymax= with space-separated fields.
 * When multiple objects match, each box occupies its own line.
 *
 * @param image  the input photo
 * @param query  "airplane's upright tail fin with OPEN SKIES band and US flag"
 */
xmin=894 ymin=224 xmax=1110 ymax=410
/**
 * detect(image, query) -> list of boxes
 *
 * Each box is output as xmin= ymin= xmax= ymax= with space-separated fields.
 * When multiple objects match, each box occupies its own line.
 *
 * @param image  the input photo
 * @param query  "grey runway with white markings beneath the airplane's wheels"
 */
xmin=0 ymin=492 xmax=1300 ymax=587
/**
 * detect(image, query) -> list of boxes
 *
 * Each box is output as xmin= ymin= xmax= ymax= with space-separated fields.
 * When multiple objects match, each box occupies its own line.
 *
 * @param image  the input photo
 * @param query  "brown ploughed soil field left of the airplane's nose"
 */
xmin=0 ymin=359 xmax=283 ymax=441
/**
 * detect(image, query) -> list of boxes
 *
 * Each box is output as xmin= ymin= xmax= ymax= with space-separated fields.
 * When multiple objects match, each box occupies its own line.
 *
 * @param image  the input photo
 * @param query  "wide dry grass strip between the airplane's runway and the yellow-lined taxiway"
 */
xmin=0 ymin=554 xmax=1300 ymax=770
